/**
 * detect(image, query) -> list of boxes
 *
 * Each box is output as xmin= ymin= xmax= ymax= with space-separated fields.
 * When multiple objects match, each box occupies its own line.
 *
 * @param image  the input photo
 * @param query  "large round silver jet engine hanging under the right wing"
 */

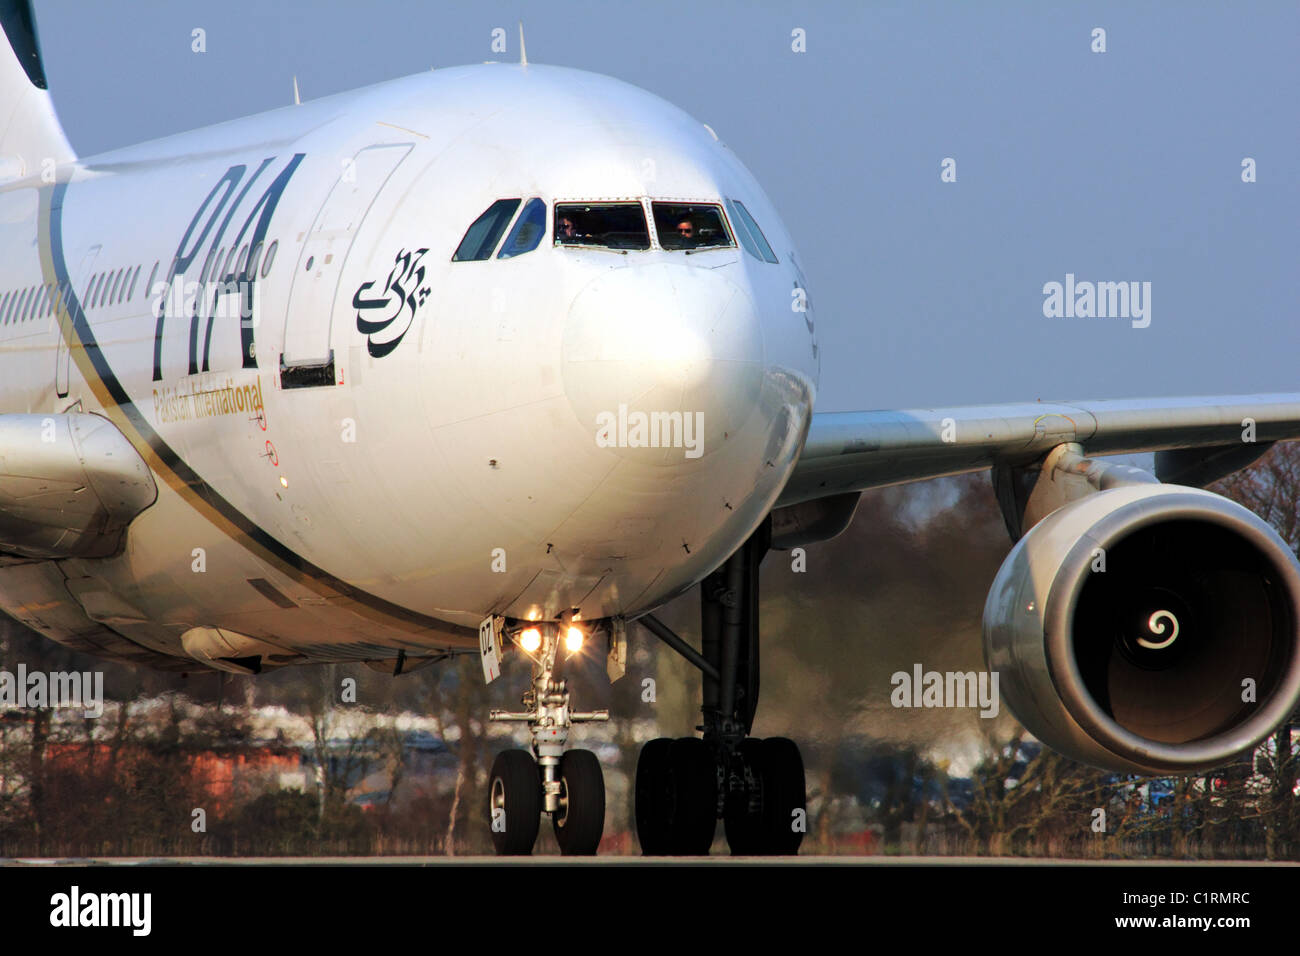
xmin=984 ymin=484 xmax=1300 ymax=774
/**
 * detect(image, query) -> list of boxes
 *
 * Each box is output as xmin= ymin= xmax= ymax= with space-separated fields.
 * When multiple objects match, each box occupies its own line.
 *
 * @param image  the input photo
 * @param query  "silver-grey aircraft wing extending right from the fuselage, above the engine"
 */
xmin=776 ymin=393 xmax=1300 ymax=507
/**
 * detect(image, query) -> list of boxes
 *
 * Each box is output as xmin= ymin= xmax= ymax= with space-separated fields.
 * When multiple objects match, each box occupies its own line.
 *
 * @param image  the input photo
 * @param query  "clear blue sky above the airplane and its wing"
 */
xmin=35 ymin=0 xmax=1300 ymax=411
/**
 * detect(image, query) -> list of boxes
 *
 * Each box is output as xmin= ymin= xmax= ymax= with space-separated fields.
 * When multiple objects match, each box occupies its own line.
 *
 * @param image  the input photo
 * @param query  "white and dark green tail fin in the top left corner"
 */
xmin=0 ymin=0 xmax=75 ymax=181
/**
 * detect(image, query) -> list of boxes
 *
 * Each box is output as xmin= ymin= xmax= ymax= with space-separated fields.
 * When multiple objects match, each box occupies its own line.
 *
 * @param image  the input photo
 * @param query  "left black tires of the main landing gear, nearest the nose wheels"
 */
xmin=636 ymin=737 xmax=718 ymax=856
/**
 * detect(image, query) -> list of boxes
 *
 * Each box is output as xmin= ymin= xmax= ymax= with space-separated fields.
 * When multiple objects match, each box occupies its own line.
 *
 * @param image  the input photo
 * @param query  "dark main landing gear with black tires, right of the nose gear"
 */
xmin=636 ymin=523 xmax=806 ymax=856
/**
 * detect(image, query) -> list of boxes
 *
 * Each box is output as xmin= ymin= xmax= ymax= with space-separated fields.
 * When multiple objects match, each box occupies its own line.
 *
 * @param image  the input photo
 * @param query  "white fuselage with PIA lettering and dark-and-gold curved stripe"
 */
xmin=0 ymin=65 xmax=818 ymax=659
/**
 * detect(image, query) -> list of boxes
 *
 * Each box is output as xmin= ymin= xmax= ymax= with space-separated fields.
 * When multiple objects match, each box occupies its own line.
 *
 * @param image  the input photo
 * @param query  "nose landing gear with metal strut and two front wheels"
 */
xmin=489 ymin=623 xmax=610 ymax=856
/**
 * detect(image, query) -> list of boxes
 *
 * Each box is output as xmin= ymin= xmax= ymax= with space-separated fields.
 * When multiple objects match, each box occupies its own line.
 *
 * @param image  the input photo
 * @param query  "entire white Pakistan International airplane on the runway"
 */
xmin=0 ymin=0 xmax=1300 ymax=855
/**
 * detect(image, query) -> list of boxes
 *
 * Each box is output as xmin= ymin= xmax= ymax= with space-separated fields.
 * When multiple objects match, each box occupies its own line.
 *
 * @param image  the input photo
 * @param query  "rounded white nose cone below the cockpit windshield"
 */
xmin=562 ymin=263 xmax=764 ymax=463
